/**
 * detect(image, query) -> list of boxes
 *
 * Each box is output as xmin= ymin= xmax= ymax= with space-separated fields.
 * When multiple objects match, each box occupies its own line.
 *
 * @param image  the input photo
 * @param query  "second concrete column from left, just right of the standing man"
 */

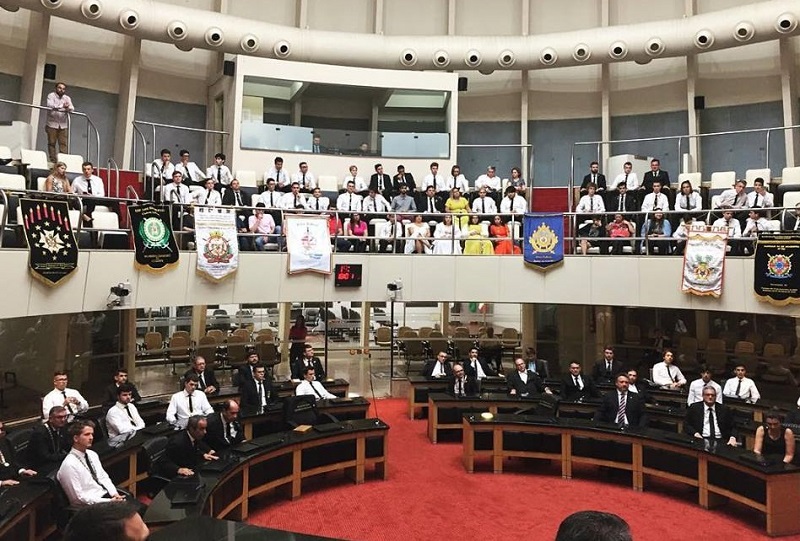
xmin=113 ymin=36 xmax=142 ymax=170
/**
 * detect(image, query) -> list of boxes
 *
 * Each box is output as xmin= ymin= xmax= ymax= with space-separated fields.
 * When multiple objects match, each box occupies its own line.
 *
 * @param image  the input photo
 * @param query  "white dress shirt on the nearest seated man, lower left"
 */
xmin=56 ymin=448 xmax=119 ymax=506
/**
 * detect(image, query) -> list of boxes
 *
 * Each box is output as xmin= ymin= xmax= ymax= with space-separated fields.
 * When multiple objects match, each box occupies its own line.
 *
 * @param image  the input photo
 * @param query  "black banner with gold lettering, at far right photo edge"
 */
xmin=753 ymin=231 xmax=800 ymax=306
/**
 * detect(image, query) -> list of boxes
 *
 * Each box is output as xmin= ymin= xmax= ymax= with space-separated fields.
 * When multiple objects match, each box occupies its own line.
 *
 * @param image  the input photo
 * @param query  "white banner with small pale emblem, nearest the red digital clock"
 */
xmin=283 ymin=214 xmax=332 ymax=274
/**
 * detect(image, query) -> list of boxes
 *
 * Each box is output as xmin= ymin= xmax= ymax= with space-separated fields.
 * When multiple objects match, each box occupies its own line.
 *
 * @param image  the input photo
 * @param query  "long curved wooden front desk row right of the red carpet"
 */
xmin=462 ymin=414 xmax=800 ymax=535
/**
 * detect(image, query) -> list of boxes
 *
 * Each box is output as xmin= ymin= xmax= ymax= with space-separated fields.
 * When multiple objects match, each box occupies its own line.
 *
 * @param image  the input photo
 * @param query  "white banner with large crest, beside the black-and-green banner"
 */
xmin=194 ymin=207 xmax=239 ymax=282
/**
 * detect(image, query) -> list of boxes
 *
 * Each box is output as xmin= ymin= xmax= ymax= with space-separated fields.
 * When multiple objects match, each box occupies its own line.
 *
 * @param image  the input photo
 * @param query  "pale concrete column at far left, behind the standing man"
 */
xmin=17 ymin=11 xmax=50 ymax=135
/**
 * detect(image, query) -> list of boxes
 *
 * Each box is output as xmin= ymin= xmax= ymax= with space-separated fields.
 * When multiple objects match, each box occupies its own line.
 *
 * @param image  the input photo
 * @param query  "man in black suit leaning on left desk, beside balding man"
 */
xmin=159 ymin=415 xmax=219 ymax=477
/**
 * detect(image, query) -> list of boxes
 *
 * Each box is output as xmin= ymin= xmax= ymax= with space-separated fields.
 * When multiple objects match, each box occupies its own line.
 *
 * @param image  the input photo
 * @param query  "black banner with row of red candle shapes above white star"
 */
xmin=19 ymin=199 xmax=78 ymax=286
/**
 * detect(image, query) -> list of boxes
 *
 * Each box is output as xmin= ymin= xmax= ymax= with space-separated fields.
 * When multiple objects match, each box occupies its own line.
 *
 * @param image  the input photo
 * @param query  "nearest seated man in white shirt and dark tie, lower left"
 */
xmin=56 ymin=420 xmax=125 ymax=506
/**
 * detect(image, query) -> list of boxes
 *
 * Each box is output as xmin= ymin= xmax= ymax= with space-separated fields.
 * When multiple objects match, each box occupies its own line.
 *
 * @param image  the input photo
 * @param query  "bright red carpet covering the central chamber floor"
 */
xmin=248 ymin=399 xmax=800 ymax=541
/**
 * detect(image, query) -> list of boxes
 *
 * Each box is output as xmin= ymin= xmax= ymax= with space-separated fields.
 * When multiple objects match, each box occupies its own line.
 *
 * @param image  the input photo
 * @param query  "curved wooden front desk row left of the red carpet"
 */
xmin=144 ymin=419 xmax=389 ymax=525
